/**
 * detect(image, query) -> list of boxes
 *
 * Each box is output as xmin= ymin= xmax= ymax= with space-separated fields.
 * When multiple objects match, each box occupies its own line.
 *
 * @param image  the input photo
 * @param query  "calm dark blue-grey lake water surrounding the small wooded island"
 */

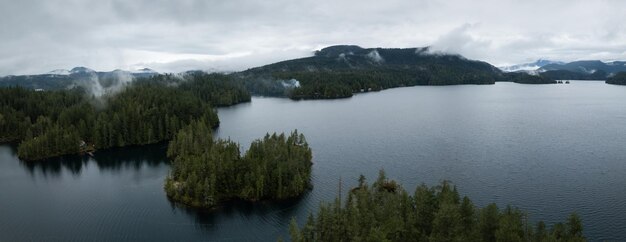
xmin=0 ymin=82 xmax=626 ymax=241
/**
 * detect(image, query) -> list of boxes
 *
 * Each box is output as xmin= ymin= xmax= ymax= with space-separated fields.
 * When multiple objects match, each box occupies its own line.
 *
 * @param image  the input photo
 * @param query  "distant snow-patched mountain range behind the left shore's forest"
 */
xmin=0 ymin=67 xmax=159 ymax=90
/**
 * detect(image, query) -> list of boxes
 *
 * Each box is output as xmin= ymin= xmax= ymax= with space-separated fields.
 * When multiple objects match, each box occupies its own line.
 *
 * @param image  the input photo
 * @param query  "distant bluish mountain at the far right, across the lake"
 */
xmin=539 ymin=60 xmax=626 ymax=80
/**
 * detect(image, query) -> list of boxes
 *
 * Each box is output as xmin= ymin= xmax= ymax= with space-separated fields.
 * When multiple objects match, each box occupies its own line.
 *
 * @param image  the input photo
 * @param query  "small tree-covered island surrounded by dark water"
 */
xmin=164 ymin=122 xmax=312 ymax=208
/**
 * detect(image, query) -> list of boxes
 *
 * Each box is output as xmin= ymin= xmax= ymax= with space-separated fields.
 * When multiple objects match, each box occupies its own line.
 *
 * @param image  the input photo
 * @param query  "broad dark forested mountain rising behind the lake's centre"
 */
xmin=236 ymin=45 xmax=554 ymax=99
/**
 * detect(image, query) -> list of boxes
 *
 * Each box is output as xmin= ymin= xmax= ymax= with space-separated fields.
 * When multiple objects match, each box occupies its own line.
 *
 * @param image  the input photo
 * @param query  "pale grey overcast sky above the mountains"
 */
xmin=0 ymin=0 xmax=626 ymax=75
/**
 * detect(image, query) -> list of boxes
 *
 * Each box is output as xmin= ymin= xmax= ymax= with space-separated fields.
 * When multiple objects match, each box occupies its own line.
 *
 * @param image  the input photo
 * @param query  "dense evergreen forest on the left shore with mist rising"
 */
xmin=0 ymin=73 xmax=250 ymax=160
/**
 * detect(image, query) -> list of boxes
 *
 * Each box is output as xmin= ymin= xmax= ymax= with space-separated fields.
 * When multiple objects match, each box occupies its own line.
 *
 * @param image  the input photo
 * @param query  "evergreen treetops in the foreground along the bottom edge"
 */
xmin=289 ymin=171 xmax=586 ymax=242
